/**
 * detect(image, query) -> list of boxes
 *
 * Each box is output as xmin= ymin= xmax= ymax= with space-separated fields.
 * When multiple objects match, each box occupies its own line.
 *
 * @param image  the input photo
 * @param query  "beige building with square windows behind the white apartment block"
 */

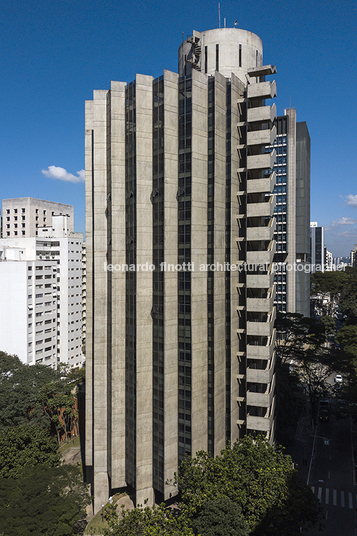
xmin=2 ymin=197 xmax=73 ymax=238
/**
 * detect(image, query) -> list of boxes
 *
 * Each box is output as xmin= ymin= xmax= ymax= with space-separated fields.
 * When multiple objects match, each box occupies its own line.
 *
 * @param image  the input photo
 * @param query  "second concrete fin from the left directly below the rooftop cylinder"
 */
xmin=214 ymin=72 xmax=226 ymax=456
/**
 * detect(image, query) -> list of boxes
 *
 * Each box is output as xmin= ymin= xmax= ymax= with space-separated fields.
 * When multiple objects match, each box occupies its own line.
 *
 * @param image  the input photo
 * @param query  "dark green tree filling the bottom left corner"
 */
xmin=0 ymin=465 xmax=90 ymax=536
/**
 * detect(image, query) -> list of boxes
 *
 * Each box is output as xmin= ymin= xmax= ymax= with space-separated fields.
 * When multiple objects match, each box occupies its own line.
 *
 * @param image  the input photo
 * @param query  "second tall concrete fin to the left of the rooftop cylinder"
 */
xmin=136 ymin=75 xmax=154 ymax=505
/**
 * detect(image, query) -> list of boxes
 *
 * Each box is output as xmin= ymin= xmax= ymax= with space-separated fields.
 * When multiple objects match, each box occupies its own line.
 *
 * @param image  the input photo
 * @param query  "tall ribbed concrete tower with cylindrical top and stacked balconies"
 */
xmin=86 ymin=28 xmax=276 ymax=511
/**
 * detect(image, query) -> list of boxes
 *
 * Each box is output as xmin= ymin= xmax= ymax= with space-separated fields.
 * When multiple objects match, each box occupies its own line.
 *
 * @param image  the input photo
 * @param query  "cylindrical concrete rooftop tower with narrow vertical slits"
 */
xmin=178 ymin=28 xmax=263 ymax=83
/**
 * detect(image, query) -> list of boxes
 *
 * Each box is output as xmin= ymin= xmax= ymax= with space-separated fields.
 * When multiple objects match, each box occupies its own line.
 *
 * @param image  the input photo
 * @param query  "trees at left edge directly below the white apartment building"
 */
xmin=0 ymin=352 xmax=58 ymax=430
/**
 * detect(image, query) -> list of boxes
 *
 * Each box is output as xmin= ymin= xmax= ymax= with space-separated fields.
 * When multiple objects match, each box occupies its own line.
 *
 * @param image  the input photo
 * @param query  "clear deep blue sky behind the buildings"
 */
xmin=0 ymin=0 xmax=357 ymax=256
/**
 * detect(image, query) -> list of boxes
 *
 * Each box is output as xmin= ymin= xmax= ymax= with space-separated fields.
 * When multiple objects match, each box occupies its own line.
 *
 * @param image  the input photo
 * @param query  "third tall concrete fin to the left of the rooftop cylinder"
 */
xmin=110 ymin=82 xmax=126 ymax=488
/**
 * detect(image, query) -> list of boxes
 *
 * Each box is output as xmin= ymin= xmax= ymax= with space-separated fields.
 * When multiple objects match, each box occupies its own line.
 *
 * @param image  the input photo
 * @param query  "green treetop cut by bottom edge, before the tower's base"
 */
xmin=104 ymin=504 xmax=194 ymax=536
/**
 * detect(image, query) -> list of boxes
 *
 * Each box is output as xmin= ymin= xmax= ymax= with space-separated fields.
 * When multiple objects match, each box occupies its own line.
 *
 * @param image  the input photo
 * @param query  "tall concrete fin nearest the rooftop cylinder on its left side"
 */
xmin=164 ymin=71 xmax=178 ymax=499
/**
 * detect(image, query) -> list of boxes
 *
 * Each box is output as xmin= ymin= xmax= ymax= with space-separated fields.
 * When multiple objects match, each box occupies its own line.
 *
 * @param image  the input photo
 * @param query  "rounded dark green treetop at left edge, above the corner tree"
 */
xmin=0 ymin=424 xmax=61 ymax=478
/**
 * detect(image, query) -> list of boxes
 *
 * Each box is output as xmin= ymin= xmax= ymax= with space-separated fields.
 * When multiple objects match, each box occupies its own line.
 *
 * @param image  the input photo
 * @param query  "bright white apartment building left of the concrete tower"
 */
xmin=0 ymin=215 xmax=84 ymax=368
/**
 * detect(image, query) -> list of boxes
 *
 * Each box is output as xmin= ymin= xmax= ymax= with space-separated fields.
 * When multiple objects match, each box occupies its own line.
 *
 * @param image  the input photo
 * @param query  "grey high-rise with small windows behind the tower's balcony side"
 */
xmin=273 ymin=108 xmax=310 ymax=316
